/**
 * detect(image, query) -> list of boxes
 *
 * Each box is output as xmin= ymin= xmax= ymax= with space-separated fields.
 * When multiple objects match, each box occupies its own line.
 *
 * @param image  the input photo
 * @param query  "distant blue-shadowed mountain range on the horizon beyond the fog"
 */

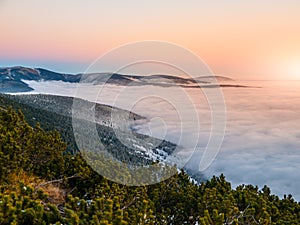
xmin=0 ymin=66 xmax=247 ymax=93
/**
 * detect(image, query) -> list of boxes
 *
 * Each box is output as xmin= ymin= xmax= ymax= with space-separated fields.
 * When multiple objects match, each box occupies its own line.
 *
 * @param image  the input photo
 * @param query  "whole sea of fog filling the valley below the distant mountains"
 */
xmin=22 ymin=81 xmax=300 ymax=201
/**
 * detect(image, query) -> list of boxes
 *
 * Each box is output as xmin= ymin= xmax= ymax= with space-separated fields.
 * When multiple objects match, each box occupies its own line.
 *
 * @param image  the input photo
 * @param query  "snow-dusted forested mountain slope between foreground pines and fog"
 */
xmin=0 ymin=94 xmax=177 ymax=165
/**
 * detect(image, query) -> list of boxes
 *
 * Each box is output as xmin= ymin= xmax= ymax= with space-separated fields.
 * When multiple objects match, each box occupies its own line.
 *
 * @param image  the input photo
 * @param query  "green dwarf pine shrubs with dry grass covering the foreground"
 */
xmin=0 ymin=107 xmax=300 ymax=225
